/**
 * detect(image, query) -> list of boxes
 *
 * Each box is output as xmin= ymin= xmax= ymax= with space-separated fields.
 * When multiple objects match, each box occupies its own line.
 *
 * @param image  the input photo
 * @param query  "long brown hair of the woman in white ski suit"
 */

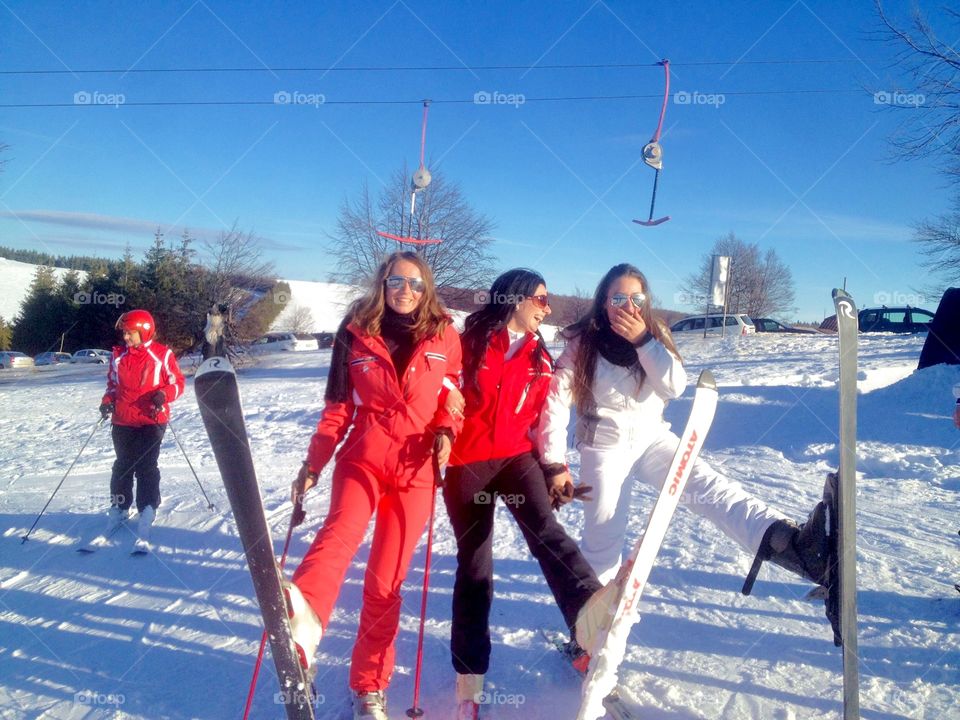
xmin=563 ymin=263 xmax=682 ymax=413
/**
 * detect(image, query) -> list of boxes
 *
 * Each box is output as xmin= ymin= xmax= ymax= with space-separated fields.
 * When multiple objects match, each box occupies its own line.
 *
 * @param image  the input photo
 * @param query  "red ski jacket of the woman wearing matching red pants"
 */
xmin=307 ymin=323 xmax=461 ymax=488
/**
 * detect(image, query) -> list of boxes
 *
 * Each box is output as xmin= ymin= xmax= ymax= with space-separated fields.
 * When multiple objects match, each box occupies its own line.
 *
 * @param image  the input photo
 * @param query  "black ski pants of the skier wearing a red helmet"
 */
xmin=110 ymin=425 xmax=167 ymax=512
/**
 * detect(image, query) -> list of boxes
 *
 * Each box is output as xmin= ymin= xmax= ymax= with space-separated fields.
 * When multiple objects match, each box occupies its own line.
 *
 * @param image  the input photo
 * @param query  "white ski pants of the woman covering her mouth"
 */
xmin=580 ymin=430 xmax=785 ymax=583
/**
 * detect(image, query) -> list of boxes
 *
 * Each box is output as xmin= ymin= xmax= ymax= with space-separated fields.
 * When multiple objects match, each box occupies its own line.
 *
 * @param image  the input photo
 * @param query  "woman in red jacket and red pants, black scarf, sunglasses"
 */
xmin=286 ymin=252 xmax=461 ymax=720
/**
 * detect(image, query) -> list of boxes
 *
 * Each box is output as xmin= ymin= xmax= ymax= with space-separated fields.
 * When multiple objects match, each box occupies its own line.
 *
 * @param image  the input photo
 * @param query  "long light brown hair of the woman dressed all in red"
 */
xmin=347 ymin=251 xmax=451 ymax=342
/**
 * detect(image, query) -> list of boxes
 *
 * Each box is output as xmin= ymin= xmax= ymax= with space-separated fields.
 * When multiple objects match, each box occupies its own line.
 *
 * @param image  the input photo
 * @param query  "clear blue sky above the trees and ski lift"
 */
xmin=0 ymin=0 xmax=956 ymax=320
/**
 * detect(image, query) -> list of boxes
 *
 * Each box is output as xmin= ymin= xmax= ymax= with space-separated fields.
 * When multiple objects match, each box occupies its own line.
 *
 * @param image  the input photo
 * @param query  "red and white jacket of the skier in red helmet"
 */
xmin=103 ymin=340 xmax=183 ymax=427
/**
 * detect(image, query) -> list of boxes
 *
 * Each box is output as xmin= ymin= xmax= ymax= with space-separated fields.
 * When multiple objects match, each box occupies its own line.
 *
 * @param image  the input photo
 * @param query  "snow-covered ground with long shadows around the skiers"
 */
xmin=0 ymin=334 xmax=960 ymax=720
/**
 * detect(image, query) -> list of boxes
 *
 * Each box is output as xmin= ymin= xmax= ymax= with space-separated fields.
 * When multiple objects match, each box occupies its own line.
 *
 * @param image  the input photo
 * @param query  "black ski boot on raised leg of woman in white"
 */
xmin=741 ymin=473 xmax=840 ymax=645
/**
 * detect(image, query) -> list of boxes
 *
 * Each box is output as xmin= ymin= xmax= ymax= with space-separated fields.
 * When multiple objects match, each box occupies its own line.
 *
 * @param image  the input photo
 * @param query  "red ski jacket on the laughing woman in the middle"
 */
xmin=450 ymin=329 xmax=553 ymax=465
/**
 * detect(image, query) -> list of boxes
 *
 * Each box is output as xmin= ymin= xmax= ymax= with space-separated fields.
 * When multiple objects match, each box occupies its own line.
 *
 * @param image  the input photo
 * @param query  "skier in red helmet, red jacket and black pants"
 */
xmin=100 ymin=310 xmax=184 ymax=537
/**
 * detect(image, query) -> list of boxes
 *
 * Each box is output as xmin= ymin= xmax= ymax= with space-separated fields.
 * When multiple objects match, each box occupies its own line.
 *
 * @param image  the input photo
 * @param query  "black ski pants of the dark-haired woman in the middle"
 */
xmin=443 ymin=453 xmax=601 ymax=674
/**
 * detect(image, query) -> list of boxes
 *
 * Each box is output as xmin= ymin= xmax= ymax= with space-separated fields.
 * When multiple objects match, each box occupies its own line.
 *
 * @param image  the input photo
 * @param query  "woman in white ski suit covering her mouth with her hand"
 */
xmin=539 ymin=264 xmax=820 ymax=583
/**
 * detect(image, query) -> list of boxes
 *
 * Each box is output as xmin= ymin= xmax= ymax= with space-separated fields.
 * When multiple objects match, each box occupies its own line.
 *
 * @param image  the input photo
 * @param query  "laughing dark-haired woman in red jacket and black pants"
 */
xmin=443 ymin=268 xmax=601 ymax=720
